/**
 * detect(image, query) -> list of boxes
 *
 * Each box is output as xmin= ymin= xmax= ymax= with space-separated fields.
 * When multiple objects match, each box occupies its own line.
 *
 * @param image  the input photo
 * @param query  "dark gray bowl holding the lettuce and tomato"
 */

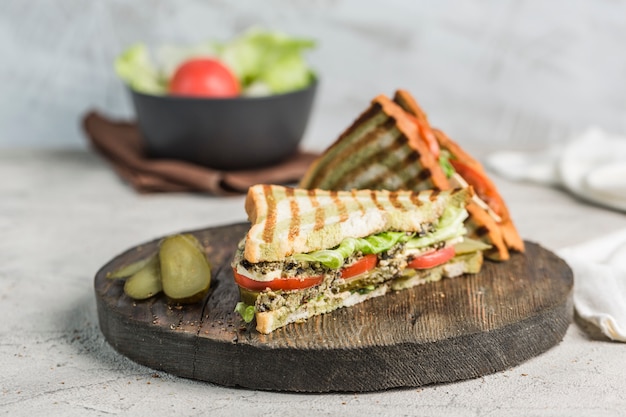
xmin=131 ymin=81 xmax=317 ymax=170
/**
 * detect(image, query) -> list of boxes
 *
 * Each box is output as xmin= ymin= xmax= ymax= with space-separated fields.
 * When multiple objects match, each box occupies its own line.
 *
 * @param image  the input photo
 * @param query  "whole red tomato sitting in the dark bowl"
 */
xmin=168 ymin=58 xmax=241 ymax=97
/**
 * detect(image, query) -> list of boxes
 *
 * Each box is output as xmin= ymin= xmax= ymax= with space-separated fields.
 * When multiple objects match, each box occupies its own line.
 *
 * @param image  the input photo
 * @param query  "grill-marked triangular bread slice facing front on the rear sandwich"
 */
xmin=300 ymin=95 xmax=451 ymax=190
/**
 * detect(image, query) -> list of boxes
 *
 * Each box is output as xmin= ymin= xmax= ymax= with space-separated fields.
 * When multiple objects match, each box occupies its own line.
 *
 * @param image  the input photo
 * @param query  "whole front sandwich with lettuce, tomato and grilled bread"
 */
xmin=232 ymin=184 xmax=487 ymax=334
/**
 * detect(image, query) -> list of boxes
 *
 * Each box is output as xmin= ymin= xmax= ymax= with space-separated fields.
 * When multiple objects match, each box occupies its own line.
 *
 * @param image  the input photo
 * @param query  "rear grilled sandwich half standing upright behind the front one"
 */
xmin=299 ymin=90 xmax=524 ymax=261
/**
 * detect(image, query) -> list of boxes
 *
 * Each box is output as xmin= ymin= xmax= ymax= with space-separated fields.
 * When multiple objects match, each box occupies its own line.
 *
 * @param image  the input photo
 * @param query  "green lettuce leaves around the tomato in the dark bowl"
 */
xmin=114 ymin=28 xmax=316 ymax=96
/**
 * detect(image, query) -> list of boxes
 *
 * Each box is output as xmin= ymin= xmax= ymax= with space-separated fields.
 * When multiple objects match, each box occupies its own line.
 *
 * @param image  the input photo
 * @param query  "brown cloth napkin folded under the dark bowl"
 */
xmin=83 ymin=111 xmax=317 ymax=195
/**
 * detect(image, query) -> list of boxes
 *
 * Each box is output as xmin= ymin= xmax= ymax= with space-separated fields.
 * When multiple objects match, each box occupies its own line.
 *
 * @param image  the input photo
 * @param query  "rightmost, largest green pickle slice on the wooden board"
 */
xmin=159 ymin=234 xmax=211 ymax=303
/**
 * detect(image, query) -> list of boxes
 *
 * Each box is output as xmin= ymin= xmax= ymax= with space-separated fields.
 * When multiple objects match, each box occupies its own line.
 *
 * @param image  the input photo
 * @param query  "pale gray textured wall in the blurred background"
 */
xmin=0 ymin=0 xmax=626 ymax=148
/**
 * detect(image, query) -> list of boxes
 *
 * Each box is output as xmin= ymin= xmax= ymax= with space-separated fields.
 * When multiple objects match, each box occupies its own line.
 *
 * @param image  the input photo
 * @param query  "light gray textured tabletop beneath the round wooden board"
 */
xmin=0 ymin=149 xmax=626 ymax=416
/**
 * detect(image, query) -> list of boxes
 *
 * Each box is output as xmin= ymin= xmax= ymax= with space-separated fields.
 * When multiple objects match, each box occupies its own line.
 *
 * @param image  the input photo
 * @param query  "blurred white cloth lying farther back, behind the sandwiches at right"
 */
xmin=485 ymin=128 xmax=626 ymax=211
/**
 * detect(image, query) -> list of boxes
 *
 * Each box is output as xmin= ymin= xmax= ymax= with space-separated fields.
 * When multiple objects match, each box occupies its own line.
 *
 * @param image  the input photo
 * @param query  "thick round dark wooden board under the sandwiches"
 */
xmin=95 ymin=223 xmax=573 ymax=392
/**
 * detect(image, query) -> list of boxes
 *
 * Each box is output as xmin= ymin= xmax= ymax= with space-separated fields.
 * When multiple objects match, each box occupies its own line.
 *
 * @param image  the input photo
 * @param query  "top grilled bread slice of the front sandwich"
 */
xmin=244 ymin=184 xmax=473 ymax=263
